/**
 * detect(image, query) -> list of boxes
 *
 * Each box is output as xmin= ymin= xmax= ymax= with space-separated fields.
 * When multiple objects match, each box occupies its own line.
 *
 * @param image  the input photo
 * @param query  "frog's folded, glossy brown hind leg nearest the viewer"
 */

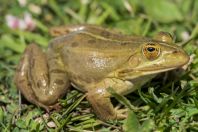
xmin=15 ymin=44 xmax=69 ymax=111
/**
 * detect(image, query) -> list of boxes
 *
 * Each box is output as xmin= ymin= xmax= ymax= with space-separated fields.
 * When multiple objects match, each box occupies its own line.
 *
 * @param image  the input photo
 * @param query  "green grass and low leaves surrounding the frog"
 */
xmin=0 ymin=0 xmax=198 ymax=132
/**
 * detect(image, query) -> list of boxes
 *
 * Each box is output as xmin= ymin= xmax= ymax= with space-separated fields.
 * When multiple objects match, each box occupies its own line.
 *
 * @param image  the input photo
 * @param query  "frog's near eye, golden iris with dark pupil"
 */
xmin=142 ymin=44 xmax=160 ymax=60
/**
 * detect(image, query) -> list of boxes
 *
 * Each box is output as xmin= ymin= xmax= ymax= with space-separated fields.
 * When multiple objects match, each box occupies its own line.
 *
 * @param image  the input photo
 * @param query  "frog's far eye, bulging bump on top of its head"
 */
xmin=154 ymin=32 xmax=173 ymax=44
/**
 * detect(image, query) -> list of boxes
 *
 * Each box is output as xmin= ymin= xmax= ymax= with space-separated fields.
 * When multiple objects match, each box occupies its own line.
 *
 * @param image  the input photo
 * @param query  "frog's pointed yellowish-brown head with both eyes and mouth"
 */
xmin=119 ymin=32 xmax=189 ymax=79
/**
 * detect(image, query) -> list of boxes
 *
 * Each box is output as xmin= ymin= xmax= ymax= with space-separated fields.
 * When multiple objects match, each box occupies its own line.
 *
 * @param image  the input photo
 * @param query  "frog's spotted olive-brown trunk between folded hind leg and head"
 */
xmin=48 ymin=32 xmax=143 ymax=85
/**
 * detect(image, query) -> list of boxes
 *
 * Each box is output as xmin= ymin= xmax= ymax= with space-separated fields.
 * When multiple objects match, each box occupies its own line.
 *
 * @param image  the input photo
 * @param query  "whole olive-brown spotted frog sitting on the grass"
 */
xmin=14 ymin=24 xmax=189 ymax=121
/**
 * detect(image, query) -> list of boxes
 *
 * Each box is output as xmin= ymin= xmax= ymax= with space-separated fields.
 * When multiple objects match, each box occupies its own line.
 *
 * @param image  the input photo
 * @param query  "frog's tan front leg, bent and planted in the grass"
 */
xmin=87 ymin=78 xmax=135 ymax=120
